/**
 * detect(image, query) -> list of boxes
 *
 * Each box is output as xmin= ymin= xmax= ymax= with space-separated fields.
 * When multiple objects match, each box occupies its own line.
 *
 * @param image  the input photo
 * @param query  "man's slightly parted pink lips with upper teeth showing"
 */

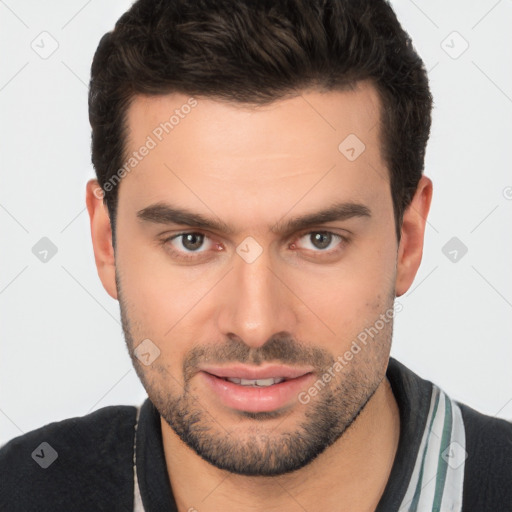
xmin=199 ymin=365 xmax=313 ymax=412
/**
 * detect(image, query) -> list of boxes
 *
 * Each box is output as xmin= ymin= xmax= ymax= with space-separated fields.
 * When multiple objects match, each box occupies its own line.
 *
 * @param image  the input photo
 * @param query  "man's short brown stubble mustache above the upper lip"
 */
xmin=183 ymin=333 xmax=335 ymax=380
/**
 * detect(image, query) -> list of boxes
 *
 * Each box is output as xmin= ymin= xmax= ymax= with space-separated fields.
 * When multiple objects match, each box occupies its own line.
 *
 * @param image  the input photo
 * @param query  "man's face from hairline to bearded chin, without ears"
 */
xmin=115 ymin=84 xmax=397 ymax=475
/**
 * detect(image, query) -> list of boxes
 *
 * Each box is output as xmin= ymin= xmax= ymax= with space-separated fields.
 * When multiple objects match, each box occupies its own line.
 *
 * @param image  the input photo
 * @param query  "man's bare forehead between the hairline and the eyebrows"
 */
xmin=119 ymin=82 xmax=389 ymax=225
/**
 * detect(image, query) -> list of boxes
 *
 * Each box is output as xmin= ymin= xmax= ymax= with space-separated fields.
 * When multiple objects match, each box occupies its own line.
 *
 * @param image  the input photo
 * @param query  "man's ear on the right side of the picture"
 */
xmin=395 ymin=176 xmax=432 ymax=297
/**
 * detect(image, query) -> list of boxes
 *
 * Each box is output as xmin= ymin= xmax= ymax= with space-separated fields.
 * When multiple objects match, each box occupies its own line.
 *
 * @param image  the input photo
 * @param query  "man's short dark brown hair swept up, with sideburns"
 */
xmin=89 ymin=0 xmax=432 ymax=238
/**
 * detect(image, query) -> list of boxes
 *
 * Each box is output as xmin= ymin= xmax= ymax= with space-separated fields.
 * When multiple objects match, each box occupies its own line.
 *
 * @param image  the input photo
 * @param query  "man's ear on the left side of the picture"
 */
xmin=86 ymin=180 xmax=117 ymax=299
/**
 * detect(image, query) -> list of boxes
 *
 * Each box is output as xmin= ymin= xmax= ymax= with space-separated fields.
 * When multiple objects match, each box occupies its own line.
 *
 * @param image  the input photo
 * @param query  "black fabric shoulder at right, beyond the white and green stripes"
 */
xmin=458 ymin=403 xmax=512 ymax=511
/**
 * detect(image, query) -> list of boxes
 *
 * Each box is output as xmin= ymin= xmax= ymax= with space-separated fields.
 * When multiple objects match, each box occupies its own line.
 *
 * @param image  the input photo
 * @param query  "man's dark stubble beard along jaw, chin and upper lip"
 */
xmin=118 ymin=272 xmax=393 ymax=477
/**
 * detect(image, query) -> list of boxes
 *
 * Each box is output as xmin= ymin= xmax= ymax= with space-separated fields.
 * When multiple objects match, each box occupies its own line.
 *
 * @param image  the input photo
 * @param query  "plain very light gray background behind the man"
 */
xmin=0 ymin=0 xmax=512 ymax=444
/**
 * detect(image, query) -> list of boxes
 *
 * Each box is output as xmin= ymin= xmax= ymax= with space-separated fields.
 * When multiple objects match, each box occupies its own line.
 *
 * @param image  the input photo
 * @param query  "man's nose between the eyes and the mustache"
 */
xmin=218 ymin=246 xmax=297 ymax=348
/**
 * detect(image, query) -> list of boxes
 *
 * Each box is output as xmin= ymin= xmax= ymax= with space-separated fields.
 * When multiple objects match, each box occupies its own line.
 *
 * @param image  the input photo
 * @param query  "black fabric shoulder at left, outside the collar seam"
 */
xmin=0 ymin=406 xmax=137 ymax=512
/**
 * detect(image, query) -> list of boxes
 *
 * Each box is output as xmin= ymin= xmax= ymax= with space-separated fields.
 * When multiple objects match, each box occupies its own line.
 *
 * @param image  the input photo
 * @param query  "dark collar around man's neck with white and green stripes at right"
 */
xmin=133 ymin=358 xmax=467 ymax=512
